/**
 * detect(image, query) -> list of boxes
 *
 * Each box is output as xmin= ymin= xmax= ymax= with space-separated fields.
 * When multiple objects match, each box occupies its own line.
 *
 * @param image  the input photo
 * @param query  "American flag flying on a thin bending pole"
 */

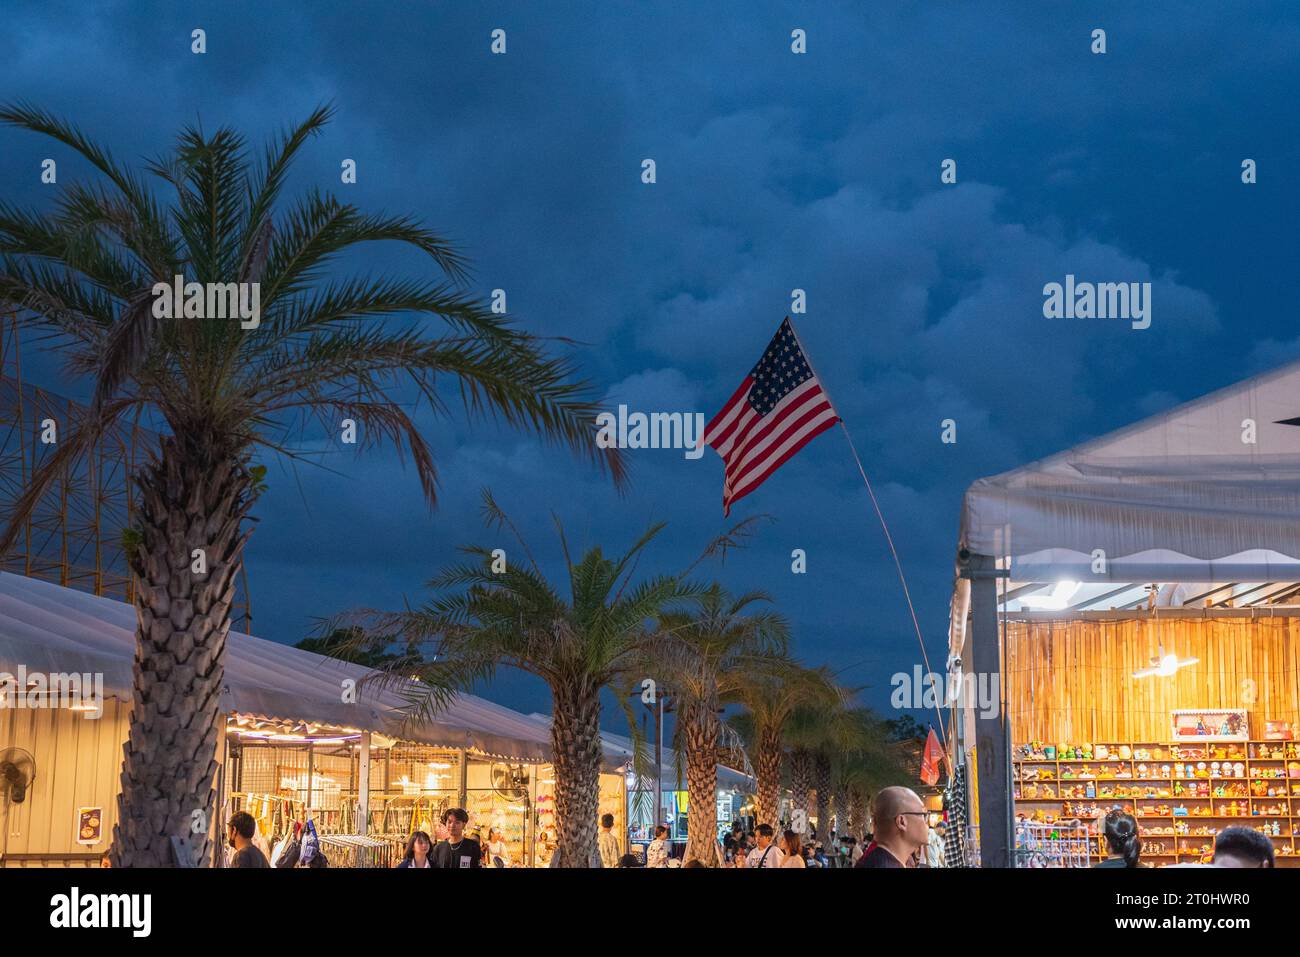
xmin=705 ymin=316 xmax=840 ymax=515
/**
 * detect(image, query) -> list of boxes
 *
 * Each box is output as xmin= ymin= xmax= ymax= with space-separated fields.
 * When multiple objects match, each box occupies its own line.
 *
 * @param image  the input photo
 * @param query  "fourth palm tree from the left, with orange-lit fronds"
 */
xmin=724 ymin=661 xmax=842 ymax=827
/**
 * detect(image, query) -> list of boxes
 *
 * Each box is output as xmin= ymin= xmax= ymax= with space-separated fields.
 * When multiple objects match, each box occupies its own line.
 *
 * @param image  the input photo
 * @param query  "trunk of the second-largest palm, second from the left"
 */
xmin=551 ymin=683 xmax=601 ymax=867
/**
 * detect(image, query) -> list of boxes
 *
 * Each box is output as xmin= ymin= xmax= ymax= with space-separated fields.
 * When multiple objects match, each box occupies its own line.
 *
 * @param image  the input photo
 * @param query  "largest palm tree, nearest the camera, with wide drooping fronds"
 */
xmin=0 ymin=104 xmax=621 ymax=866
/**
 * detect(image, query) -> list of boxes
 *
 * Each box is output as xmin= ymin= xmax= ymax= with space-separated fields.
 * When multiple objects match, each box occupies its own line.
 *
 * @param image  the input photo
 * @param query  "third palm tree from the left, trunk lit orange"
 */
xmin=650 ymin=584 xmax=789 ymax=866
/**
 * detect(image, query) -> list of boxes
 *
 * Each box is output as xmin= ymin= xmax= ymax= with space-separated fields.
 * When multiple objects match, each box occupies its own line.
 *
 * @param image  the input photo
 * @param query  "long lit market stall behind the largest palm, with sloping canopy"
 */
xmin=0 ymin=572 xmax=550 ymax=867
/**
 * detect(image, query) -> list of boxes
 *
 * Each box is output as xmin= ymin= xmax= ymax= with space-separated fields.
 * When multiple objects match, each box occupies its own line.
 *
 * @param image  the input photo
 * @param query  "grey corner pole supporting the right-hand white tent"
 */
xmin=962 ymin=555 xmax=1015 ymax=867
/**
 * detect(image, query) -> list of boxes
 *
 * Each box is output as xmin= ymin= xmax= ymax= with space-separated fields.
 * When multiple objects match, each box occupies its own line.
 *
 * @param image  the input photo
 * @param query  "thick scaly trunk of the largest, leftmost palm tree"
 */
xmin=111 ymin=429 xmax=252 ymax=867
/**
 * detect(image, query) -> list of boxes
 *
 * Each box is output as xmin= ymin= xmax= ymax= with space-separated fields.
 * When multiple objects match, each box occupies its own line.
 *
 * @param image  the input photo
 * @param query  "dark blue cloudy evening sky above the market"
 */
xmin=0 ymin=1 xmax=1300 ymax=723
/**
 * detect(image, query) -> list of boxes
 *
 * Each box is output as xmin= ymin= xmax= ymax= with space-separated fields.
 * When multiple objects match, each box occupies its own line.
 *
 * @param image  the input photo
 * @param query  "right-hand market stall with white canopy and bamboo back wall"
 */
xmin=949 ymin=363 xmax=1300 ymax=866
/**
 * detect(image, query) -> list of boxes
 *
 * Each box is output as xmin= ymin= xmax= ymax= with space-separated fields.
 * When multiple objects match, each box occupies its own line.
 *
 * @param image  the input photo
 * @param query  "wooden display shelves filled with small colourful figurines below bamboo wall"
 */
xmin=1011 ymin=740 xmax=1300 ymax=867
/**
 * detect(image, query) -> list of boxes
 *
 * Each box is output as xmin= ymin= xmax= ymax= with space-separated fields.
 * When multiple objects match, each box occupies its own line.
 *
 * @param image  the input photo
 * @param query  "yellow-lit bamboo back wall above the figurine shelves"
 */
xmin=1004 ymin=618 xmax=1300 ymax=744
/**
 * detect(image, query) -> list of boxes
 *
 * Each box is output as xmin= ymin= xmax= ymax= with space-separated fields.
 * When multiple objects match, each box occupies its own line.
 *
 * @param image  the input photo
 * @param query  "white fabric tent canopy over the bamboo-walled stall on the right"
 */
xmin=961 ymin=363 xmax=1300 ymax=583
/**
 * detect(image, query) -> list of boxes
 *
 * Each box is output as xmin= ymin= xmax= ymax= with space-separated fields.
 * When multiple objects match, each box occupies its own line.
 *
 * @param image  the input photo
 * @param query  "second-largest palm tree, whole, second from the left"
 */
xmin=358 ymin=492 xmax=699 ymax=867
